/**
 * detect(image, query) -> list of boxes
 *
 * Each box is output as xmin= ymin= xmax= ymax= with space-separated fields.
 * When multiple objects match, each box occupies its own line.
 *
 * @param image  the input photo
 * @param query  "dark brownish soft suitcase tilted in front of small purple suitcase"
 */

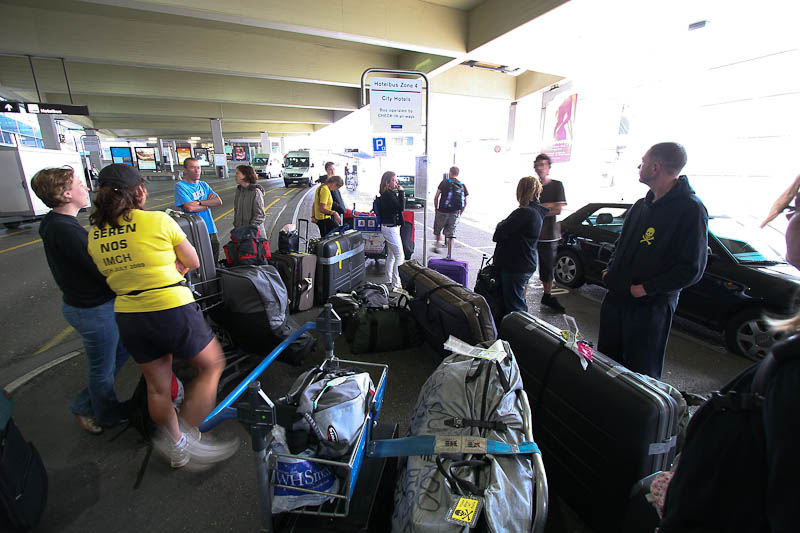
xmin=400 ymin=259 xmax=497 ymax=357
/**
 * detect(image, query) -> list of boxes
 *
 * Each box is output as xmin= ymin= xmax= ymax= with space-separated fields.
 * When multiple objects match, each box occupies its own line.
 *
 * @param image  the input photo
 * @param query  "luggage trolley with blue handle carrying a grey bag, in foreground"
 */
xmin=200 ymin=304 xmax=388 ymax=532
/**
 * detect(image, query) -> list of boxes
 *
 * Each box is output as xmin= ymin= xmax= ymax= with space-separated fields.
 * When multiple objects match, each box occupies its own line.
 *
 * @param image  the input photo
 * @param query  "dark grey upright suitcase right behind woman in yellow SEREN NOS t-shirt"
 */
xmin=168 ymin=210 xmax=222 ymax=311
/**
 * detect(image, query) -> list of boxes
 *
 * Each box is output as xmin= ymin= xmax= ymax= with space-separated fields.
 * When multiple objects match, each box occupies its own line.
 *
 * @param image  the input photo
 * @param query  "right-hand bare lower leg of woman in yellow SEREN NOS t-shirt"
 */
xmin=181 ymin=338 xmax=225 ymax=427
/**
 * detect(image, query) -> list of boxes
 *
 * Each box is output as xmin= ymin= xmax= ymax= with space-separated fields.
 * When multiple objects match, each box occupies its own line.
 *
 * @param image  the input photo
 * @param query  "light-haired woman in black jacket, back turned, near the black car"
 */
xmin=492 ymin=176 xmax=550 ymax=313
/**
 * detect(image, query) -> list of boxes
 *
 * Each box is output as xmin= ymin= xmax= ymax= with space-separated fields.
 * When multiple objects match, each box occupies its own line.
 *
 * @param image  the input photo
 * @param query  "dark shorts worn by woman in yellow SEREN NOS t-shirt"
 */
xmin=115 ymin=302 xmax=214 ymax=365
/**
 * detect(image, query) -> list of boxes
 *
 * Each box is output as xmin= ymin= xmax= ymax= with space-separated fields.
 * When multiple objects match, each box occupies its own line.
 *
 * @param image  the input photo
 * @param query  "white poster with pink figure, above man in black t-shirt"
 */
xmin=542 ymin=83 xmax=578 ymax=163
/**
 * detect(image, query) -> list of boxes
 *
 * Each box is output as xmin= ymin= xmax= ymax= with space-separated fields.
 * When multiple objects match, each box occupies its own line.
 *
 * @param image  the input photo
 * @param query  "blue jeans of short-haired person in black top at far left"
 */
xmin=61 ymin=300 xmax=128 ymax=426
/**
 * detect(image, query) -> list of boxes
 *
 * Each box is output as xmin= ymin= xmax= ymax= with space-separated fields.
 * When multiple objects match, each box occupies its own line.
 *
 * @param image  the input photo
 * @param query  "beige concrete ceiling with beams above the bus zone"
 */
xmin=0 ymin=0 xmax=567 ymax=138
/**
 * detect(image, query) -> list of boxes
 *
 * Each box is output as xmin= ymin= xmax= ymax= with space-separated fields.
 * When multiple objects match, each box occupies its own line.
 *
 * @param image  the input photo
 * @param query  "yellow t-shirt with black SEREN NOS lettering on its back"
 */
xmin=89 ymin=209 xmax=194 ymax=313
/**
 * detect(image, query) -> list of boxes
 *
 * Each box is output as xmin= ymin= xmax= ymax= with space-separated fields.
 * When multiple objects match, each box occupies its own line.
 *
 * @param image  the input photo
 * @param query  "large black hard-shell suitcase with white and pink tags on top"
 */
xmin=500 ymin=312 xmax=679 ymax=531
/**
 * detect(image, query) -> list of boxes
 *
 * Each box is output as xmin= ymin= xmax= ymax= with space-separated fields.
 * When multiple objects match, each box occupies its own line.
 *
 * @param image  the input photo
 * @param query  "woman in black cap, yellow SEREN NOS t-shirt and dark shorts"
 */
xmin=89 ymin=164 xmax=238 ymax=468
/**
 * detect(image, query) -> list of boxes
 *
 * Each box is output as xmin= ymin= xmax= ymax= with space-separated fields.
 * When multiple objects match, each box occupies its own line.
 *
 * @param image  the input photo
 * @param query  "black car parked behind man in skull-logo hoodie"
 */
xmin=555 ymin=203 xmax=800 ymax=359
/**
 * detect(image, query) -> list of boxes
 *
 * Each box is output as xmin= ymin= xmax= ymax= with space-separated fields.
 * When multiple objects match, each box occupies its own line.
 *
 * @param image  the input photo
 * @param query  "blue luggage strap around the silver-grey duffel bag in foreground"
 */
xmin=367 ymin=435 xmax=542 ymax=457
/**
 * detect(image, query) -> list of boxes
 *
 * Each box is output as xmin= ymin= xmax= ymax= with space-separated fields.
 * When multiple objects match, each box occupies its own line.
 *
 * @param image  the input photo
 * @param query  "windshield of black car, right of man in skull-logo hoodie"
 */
xmin=708 ymin=217 xmax=786 ymax=265
